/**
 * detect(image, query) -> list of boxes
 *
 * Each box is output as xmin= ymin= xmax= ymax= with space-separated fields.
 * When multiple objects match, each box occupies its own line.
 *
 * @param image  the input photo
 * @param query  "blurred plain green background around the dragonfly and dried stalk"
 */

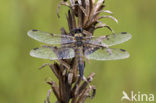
xmin=0 ymin=0 xmax=156 ymax=103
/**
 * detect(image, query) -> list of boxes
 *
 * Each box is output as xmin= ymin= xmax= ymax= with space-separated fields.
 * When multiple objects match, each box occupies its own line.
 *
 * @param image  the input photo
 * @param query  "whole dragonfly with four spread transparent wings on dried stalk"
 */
xmin=28 ymin=28 xmax=131 ymax=77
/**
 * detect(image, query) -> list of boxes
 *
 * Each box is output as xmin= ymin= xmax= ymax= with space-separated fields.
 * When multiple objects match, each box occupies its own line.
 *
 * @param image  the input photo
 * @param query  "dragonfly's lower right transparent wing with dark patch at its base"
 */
xmin=85 ymin=47 xmax=129 ymax=60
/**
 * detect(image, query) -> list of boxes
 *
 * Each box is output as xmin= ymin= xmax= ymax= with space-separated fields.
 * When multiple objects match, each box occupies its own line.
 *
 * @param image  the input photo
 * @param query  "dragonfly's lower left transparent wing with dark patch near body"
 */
xmin=30 ymin=46 xmax=75 ymax=60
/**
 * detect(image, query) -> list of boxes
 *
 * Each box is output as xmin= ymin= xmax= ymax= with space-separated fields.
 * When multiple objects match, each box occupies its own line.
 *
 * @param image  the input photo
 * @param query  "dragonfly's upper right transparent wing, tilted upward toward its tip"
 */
xmin=89 ymin=32 xmax=132 ymax=46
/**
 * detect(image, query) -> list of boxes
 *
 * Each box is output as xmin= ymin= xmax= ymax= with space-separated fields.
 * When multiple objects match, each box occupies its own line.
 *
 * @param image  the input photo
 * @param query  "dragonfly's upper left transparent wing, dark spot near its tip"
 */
xmin=28 ymin=30 xmax=74 ymax=44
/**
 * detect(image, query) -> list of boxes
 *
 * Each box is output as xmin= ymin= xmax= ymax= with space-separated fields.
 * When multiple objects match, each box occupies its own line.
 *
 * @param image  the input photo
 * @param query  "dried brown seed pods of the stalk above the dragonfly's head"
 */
xmin=59 ymin=0 xmax=118 ymax=34
